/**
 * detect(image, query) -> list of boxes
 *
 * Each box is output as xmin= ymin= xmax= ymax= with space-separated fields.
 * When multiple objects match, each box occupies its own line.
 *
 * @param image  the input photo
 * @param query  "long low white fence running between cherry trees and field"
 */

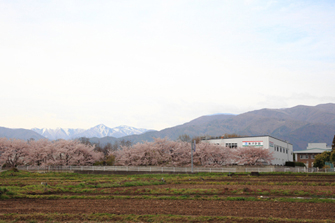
xmin=18 ymin=166 xmax=335 ymax=173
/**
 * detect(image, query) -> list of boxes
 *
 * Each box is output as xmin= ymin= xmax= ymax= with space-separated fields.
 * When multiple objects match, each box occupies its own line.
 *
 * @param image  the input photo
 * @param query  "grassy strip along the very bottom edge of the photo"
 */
xmin=0 ymin=213 xmax=333 ymax=223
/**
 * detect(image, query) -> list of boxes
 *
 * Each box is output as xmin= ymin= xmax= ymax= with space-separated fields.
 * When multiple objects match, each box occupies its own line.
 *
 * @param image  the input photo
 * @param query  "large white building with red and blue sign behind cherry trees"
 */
xmin=202 ymin=135 xmax=293 ymax=165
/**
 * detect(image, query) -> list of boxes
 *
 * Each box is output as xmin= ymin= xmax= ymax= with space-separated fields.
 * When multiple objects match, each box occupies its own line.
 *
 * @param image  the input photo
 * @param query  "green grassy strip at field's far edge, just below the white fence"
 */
xmin=0 ymin=171 xmax=335 ymax=186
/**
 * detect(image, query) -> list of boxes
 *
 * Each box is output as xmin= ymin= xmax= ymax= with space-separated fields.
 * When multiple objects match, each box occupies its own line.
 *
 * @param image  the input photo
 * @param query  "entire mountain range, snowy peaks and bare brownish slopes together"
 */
xmin=0 ymin=103 xmax=335 ymax=150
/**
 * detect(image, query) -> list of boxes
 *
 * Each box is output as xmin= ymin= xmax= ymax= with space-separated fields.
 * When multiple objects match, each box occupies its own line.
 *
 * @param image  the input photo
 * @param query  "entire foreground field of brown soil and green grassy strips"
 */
xmin=0 ymin=171 xmax=335 ymax=222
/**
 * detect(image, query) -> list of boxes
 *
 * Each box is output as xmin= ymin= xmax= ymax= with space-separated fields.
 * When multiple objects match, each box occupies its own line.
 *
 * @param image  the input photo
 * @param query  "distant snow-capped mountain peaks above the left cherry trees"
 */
xmin=32 ymin=124 xmax=150 ymax=140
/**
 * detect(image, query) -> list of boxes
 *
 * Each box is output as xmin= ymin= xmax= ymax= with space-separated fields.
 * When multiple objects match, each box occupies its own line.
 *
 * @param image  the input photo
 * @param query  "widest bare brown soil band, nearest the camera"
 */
xmin=0 ymin=199 xmax=335 ymax=220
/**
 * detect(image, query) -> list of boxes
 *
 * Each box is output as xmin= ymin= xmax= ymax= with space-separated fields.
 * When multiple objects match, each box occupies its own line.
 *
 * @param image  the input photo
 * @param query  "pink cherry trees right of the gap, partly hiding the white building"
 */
xmin=113 ymin=138 xmax=274 ymax=166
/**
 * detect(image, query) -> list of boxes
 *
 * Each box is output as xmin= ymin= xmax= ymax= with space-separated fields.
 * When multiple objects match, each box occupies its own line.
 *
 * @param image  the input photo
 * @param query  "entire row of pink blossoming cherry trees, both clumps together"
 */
xmin=0 ymin=138 xmax=273 ymax=167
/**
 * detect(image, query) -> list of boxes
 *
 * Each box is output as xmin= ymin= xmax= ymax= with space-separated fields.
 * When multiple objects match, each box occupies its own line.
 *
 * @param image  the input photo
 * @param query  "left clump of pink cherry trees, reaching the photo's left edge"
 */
xmin=0 ymin=138 xmax=103 ymax=167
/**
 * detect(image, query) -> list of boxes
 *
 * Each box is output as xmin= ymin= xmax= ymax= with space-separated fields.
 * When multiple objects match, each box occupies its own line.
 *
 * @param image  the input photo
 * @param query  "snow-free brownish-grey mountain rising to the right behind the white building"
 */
xmin=91 ymin=103 xmax=335 ymax=150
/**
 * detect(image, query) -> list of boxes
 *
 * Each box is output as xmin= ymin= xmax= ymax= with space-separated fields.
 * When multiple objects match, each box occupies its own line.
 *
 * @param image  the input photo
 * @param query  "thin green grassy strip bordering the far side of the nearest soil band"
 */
xmin=7 ymin=195 xmax=335 ymax=203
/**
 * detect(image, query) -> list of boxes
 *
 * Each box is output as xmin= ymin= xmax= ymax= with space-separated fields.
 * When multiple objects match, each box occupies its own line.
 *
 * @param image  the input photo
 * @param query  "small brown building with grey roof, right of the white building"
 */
xmin=294 ymin=143 xmax=332 ymax=168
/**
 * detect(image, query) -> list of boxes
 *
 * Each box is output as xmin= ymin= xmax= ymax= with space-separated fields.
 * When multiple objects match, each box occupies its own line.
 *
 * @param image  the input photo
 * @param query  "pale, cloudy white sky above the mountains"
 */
xmin=0 ymin=0 xmax=335 ymax=130
